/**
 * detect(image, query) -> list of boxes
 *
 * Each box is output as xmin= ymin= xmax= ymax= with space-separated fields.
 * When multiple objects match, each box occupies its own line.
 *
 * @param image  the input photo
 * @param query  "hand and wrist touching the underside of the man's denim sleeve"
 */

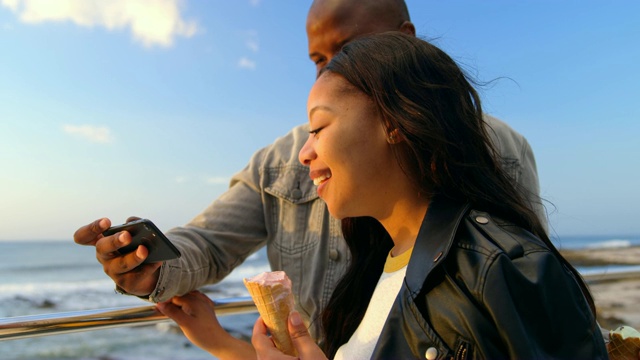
xmin=157 ymin=291 xmax=256 ymax=359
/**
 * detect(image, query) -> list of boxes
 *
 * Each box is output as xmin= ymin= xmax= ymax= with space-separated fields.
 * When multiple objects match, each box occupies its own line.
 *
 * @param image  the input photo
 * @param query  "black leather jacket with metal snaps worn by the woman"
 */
xmin=373 ymin=199 xmax=608 ymax=359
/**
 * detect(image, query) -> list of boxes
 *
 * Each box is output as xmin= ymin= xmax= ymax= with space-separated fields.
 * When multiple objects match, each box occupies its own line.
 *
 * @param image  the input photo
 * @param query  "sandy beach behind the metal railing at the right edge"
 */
xmin=561 ymin=247 xmax=640 ymax=330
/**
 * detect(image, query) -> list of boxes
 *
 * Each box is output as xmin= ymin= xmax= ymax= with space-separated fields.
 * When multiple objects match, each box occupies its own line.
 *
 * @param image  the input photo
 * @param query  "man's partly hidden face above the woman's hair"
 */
xmin=307 ymin=3 xmax=401 ymax=75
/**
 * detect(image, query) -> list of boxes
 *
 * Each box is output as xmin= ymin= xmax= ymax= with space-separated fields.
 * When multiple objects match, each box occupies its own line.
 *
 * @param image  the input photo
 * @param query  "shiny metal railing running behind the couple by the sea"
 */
xmin=0 ymin=266 xmax=640 ymax=341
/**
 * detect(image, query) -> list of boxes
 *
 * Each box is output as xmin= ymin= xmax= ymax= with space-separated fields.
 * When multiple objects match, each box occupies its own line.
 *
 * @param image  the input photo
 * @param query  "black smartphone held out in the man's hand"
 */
xmin=102 ymin=219 xmax=180 ymax=263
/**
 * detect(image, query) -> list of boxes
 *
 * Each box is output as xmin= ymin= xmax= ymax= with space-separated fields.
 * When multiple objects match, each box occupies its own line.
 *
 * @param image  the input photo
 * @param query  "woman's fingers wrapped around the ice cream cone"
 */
xmin=251 ymin=311 xmax=327 ymax=360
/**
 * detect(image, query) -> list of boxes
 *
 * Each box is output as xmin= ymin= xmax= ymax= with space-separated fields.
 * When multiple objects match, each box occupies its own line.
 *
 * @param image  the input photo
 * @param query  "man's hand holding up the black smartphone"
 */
xmin=73 ymin=218 xmax=162 ymax=296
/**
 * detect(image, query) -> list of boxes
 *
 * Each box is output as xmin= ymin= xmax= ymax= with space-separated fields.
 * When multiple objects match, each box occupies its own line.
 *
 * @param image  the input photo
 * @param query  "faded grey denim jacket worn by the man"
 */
xmin=142 ymin=116 xmax=546 ymax=333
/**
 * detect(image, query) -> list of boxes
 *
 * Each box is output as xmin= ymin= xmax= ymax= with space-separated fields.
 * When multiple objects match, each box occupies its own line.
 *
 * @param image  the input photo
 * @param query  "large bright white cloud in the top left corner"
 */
xmin=0 ymin=0 xmax=200 ymax=47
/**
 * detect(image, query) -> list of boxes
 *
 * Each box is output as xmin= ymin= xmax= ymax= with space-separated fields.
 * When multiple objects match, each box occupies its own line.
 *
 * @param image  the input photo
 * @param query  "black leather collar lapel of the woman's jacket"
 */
xmin=405 ymin=196 xmax=470 ymax=297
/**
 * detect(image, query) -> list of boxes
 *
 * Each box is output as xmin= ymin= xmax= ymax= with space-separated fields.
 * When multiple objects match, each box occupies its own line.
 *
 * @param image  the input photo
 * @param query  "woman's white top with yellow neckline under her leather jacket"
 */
xmin=334 ymin=248 xmax=413 ymax=360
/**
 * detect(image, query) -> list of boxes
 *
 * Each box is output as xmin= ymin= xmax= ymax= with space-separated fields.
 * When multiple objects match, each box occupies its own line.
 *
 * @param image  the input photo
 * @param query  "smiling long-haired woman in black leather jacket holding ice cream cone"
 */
xmin=158 ymin=33 xmax=607 ymax=359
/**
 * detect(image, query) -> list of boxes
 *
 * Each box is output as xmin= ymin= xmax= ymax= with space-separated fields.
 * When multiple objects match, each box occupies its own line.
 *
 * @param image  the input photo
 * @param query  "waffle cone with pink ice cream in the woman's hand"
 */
xmin=243 ymin=271 xmax=298 ymax=356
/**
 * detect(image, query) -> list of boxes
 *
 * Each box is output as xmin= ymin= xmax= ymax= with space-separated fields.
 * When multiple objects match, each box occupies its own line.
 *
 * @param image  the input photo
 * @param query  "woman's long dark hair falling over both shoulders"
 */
xmin=320 ymin=32 xmax=595 ymax=358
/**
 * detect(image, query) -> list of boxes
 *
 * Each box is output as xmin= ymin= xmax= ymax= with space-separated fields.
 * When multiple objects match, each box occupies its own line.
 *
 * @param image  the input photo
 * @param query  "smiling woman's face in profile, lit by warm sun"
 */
xmin=299 ymin=72 xmax=399 ymax=219
